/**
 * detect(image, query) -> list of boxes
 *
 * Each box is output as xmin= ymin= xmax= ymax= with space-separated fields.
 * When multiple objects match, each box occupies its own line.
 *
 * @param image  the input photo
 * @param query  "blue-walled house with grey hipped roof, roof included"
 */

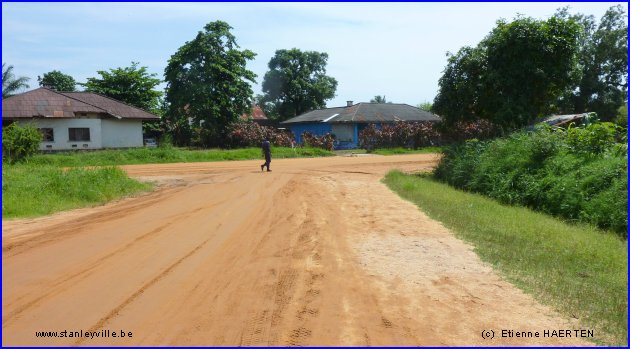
xmin=280 ymin=101 xmax=440 ymax=149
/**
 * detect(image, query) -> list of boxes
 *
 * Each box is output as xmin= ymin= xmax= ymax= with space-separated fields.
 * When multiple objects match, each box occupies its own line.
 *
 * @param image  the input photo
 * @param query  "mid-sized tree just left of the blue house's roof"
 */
xmin=262 ymin=48 xmax=337 ymax=120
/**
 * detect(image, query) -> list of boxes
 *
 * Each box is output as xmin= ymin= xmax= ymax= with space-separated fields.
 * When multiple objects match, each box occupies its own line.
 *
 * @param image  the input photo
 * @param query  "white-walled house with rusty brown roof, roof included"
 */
xmin=2 ymin=87 xmax=159 ymax=150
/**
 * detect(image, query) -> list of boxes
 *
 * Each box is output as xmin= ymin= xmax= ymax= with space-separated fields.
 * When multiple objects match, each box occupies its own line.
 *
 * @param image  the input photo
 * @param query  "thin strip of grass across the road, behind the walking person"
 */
xmin=28 ymin=147 xmax=334 ymax=166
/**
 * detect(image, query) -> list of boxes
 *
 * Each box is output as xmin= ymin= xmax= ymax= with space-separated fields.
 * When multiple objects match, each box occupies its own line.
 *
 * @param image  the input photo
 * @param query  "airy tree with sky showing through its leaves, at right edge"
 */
xmin=557 ymin=5 xmax=628 ymax=121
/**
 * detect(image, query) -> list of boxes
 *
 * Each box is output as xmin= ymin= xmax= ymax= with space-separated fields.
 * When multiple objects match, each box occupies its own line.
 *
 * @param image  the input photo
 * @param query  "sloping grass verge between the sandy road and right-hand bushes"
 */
xmin=384 ymin=171 xmax=628 ymax=346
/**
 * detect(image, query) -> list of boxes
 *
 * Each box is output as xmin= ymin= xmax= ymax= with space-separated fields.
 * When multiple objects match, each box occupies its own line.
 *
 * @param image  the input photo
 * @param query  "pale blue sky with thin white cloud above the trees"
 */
xmin=2 ymin=2 xmax=628 ymax=107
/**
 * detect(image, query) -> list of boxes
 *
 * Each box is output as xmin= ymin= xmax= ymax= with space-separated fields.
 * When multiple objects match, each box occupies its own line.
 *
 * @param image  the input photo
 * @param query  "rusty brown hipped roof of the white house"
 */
xmin=2 ymin=87 xmax=159 ymax=120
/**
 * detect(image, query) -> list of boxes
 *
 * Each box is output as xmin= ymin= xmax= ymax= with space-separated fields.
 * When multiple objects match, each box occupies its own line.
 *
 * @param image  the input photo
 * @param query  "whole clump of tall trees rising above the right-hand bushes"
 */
xmin=432 ymin=6 xmax=628 ymax=131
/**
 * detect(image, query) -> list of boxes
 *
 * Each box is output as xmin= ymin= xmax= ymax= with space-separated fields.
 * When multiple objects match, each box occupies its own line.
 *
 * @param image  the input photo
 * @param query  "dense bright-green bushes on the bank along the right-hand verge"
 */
xmin=435 ymin=122 xmax=628 ymax=236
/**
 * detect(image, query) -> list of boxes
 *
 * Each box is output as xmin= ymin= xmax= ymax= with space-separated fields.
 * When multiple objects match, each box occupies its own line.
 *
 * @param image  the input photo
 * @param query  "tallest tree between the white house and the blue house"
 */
xmin=164 ymin=21 xmax=256 ymax=146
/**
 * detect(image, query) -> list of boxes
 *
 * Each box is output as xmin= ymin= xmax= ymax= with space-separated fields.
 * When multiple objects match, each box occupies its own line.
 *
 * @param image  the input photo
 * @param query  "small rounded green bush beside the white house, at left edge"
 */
xmin=2 ymin=123 xmax=42 ymax=163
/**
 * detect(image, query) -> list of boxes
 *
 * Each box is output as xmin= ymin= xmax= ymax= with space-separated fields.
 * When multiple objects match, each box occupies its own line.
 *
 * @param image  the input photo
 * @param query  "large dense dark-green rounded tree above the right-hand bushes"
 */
xmin=433 ymin=17 xmax=580 ymax=129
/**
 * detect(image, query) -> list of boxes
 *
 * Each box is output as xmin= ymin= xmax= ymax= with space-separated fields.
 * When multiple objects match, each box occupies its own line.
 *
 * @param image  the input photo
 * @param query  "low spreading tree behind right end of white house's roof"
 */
xmin=79 ymin=62 xmax=162 ymax=112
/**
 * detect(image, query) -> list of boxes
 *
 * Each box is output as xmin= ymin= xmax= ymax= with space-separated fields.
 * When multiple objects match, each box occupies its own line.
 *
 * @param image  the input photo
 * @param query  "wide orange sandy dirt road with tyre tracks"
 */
xmin=2 ymin=155 xmax=588 ymax=346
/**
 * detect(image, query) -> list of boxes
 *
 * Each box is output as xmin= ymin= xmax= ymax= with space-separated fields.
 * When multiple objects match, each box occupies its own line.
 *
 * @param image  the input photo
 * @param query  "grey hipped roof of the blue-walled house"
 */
xmin=282 ymin=103 xmax=440 ymax=124
